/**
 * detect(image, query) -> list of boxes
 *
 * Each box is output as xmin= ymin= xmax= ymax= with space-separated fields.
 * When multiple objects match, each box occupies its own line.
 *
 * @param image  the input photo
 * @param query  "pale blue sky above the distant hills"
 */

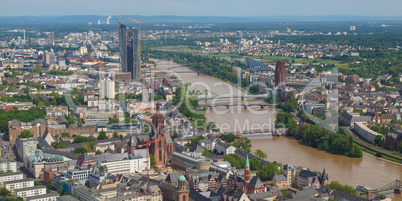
xmin=0 ymin=0 xmax=402 ymax=16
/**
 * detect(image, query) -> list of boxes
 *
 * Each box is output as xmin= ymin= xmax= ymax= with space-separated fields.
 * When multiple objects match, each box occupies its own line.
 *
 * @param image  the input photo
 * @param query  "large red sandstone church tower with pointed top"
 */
xmin=149 ymin=102 xmax=169 ymax=166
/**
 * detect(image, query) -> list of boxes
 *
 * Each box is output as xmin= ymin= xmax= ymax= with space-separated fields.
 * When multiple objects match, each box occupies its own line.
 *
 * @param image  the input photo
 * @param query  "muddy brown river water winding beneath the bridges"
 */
xmin=152 ymin=61 xmax=402 ymax=201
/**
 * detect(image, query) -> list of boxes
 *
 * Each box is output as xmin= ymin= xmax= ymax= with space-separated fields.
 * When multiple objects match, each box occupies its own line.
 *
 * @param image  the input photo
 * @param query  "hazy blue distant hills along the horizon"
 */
xmin=0 ymin=15 xmax=402 ymax=25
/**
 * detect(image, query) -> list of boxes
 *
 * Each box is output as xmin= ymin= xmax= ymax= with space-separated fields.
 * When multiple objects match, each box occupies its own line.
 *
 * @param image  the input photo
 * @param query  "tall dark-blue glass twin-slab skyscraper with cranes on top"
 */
xmin=119 ymin=24 xmax=141 ymax=80
